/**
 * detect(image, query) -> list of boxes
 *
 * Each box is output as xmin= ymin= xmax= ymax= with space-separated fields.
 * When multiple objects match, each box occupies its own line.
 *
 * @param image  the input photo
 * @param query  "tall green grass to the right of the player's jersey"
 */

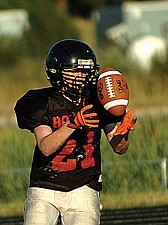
xmin=101 ymin=116 xmax=168 ymax=194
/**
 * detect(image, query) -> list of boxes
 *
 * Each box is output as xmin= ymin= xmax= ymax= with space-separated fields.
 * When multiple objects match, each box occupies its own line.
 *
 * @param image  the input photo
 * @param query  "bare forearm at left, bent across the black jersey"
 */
xmin=38 ymin=123 xmax=74 ymax=156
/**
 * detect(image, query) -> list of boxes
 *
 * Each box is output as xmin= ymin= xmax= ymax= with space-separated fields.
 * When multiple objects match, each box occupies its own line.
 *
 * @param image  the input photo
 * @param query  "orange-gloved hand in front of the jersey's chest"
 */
xmin=68 ymin=104 xmax=99 ymax=129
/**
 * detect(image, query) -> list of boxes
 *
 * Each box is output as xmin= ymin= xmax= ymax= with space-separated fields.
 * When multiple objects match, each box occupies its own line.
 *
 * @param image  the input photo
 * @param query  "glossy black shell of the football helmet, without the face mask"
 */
xmin=46 ymin=39 xmax=99 ymax=93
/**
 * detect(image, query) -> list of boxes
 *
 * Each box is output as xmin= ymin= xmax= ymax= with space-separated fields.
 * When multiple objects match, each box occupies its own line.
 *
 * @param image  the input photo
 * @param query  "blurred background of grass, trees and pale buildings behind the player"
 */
xmin=0 ymin=0 xmax=168 ymax=216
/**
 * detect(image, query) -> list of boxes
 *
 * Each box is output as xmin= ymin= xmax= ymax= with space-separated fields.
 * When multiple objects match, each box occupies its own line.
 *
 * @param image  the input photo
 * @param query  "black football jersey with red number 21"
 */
xmin=15 ymin=87 xmax=122 ymax=191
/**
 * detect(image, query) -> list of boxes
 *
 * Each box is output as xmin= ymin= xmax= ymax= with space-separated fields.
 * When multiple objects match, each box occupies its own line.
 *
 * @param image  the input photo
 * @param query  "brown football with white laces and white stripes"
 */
xmin=97 ymin=67 xmax=129 ymax=116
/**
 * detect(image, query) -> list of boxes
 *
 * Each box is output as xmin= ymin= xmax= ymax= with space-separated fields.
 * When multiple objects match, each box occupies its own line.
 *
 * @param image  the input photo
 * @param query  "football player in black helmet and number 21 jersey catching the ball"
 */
xmin=15 ymin=39 xmax=135 ymax=225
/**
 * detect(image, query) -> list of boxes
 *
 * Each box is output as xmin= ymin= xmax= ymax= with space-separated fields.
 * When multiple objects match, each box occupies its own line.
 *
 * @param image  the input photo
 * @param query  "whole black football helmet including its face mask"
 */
xmin=46 ymin=39 xmax=100 ymax=100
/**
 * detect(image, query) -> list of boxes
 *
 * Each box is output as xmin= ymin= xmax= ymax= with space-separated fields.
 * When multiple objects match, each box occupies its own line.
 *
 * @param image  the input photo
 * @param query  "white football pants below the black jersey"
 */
xmin=24 ymin=185 xmax=100 ymax=225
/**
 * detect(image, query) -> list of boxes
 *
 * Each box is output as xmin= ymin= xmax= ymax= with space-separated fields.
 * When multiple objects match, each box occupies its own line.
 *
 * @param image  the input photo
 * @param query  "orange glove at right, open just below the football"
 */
xmin=113 ymin=109 xmax=137 ymax=136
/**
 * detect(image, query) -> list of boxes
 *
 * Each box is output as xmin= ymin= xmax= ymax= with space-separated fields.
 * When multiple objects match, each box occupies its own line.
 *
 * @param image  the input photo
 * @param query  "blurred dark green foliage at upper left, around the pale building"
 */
xmin=0 ymin=0 xmax=80 ymax=64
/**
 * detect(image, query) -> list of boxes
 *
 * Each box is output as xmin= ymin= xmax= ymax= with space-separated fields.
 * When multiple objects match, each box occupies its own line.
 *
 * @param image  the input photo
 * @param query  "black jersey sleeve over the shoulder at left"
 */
xmin=14 ymin=90 xmax=50 ymax=132
